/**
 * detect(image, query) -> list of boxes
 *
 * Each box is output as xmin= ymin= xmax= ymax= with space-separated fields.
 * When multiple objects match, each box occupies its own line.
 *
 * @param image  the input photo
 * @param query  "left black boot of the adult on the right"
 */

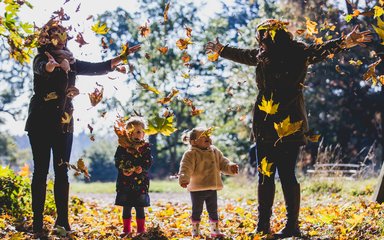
xmin=256 ymin=183 xmax=275 ymax=234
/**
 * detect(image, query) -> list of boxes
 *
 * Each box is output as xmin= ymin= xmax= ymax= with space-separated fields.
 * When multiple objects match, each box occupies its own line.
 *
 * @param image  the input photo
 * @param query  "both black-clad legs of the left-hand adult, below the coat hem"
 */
xmin=28 ymin=129 xmax=73 ymax=228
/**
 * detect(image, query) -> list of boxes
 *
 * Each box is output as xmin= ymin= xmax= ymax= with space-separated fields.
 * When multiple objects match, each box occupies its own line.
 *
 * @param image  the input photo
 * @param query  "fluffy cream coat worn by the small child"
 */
xmin=179 ymin=145 xmax=236 ymax=192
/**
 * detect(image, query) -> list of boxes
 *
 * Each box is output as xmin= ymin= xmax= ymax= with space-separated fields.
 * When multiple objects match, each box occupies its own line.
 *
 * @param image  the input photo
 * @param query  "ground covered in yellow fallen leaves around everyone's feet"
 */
xmin=0 ymin=181 xmax=384 ymax=239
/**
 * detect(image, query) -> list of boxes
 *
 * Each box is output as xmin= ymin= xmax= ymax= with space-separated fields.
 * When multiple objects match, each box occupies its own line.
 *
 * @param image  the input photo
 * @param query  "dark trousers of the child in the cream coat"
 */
xmin=191 ymin=190 xmax=219 ymax=221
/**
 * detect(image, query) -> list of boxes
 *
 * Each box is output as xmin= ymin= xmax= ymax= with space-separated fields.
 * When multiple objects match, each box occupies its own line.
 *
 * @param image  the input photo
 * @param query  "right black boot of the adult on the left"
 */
xmin=54 ymin=182 xmax=71 ymax=231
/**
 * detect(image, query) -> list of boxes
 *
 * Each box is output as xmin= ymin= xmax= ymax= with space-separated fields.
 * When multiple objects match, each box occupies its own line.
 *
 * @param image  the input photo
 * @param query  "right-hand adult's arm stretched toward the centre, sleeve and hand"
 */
xmin=205 ymin=38 xmax=258 ymax=66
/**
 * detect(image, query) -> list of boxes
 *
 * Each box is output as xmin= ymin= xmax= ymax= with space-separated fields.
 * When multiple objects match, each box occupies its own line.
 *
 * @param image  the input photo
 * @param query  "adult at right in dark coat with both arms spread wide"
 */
xmin=206 ymin=19 xmax=372 ymax=237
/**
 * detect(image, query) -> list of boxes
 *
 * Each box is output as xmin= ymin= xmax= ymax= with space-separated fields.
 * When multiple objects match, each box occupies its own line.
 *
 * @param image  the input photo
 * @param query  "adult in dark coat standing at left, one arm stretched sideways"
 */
xmin=25 ymin=19 xmax=140 ymax=235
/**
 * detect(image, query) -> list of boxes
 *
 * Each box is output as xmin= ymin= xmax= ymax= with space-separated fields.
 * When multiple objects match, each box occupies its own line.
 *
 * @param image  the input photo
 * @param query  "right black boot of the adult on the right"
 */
xmin=274 ymin=184 xmax=301 ymax=238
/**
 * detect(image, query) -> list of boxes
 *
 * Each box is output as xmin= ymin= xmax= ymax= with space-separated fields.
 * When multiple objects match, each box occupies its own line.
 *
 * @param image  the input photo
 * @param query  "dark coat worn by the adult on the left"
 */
xmin=25 ymin=53 xmax=112 ymax=132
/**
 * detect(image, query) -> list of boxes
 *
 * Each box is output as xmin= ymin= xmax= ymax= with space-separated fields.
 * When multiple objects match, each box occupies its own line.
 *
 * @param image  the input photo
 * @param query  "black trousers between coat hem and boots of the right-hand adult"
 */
xmin=257 ymin=142 xmax=300 ymax=186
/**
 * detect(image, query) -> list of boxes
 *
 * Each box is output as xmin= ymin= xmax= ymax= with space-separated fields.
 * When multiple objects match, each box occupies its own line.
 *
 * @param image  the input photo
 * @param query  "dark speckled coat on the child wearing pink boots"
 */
xmin=115 ymin=143 xmax=152 ymax=207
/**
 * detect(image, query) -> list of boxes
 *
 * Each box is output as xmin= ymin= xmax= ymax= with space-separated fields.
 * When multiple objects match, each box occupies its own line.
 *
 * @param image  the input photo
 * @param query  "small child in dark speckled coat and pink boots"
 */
xmin=115 ymin=117 xmax=152 ymax=236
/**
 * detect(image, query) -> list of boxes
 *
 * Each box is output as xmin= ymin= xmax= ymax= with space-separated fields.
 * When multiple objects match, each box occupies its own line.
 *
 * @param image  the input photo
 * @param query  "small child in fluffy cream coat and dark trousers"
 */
xmin=179 ymin=128 xmax=239 ymax=237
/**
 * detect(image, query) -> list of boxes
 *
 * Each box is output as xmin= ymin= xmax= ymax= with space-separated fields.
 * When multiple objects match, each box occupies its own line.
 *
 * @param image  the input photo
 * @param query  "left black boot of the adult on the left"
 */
xmin=31 ymin=180 xmax=47 ymax=234
